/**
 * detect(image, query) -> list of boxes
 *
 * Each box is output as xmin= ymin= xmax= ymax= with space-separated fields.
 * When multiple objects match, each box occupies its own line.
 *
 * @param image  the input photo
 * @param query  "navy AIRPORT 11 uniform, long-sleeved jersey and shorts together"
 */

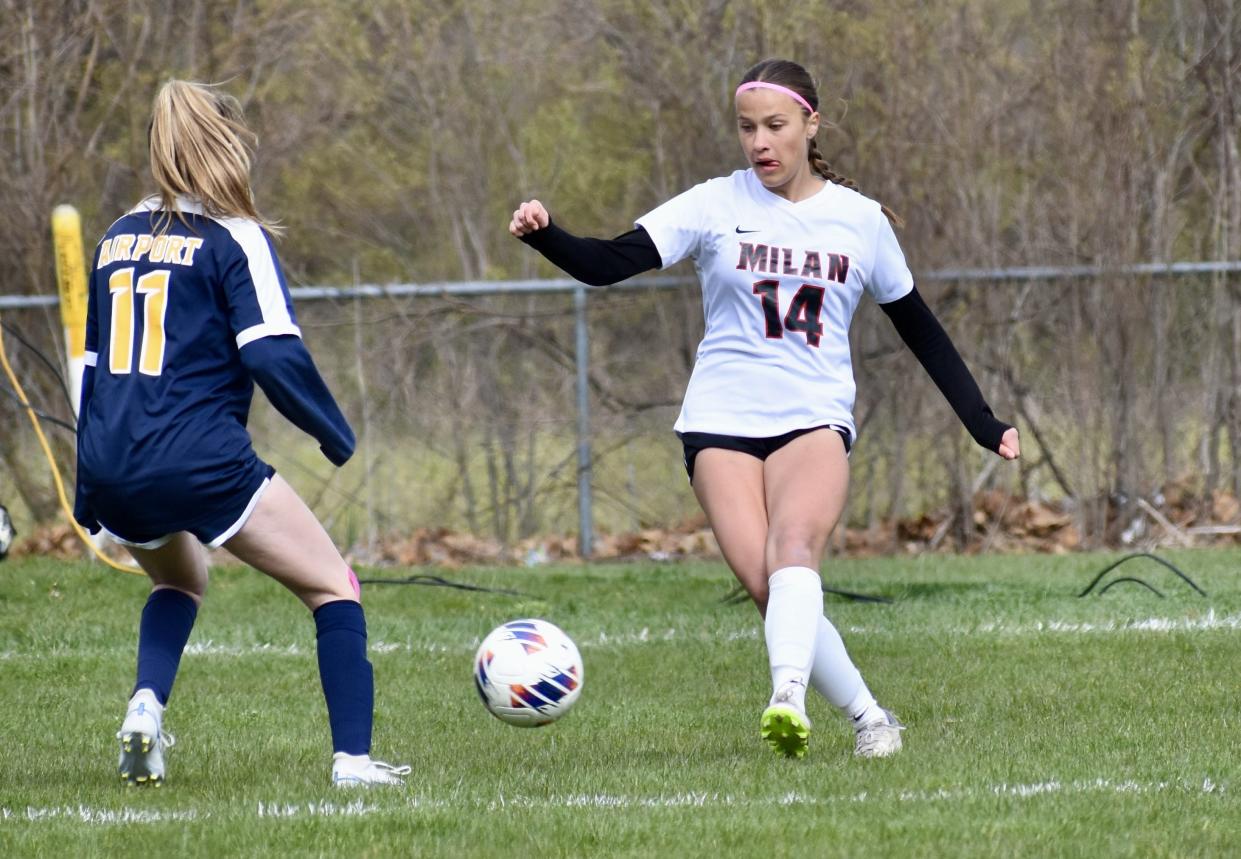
xmin=76 ymin=199 xmax=354 ymax=544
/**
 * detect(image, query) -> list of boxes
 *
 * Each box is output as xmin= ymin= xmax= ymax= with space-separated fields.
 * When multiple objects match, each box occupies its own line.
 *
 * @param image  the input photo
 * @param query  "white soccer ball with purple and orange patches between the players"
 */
xmin=474 ymin=619 xmax=583 ymax=727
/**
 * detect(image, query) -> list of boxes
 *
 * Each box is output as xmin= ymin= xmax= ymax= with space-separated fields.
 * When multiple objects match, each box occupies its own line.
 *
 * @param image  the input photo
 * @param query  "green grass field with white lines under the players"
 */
xmin=0 ymin=551 xmax=1241 ymax=857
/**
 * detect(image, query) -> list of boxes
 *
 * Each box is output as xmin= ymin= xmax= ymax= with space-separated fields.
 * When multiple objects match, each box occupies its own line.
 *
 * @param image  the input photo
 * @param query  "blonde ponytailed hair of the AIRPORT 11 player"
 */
xmin=149 ymin=79 xmax=280 ymax=235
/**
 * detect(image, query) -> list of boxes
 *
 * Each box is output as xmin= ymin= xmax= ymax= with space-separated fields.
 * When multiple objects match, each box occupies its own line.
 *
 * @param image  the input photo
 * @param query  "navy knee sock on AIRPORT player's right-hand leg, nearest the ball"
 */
xmin=314 ymin=600 xmax=375 ymax=755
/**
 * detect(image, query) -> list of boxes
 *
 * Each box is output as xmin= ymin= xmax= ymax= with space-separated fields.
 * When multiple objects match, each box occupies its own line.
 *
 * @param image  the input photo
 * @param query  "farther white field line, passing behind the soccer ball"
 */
xmin=0 ymin=608 xmax=1241 ymax=662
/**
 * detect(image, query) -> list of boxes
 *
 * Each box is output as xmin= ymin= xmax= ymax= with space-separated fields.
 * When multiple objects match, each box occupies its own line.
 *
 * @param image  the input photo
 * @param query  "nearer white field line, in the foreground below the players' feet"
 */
xmin=0 ymin=777 xmax=1229 ymax=825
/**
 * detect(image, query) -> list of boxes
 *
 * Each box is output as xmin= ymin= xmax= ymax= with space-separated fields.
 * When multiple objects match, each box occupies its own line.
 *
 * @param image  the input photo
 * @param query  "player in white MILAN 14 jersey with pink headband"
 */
xmin=509 ymin=60 xmax=1020 ymax=757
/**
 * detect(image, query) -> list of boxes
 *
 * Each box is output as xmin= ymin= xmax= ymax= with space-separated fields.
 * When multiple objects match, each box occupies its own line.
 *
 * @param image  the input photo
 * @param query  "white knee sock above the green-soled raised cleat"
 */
xmin=763 ymin=567 xmax=823 ymax=710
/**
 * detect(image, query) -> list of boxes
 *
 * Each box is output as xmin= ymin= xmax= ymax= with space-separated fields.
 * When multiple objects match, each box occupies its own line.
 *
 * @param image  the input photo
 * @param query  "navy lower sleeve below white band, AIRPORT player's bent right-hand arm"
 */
xmin=241 ymin=334 xmax=356 ymax=465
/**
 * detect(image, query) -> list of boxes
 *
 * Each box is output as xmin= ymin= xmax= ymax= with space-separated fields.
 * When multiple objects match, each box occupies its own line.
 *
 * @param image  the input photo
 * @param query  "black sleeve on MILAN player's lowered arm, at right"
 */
xmin=879 ymin=287 xmax=1011 ymax=451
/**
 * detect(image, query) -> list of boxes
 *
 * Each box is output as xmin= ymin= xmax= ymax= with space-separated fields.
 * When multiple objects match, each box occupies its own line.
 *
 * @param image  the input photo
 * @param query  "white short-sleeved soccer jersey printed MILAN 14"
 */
xmin=637 ymin=170 xmax=913 ymax=438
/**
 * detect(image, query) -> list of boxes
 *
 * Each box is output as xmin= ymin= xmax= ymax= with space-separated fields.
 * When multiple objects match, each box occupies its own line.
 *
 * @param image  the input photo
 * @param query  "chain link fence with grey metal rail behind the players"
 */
xmin=7 ymin=263 xmax=1241 ymax=555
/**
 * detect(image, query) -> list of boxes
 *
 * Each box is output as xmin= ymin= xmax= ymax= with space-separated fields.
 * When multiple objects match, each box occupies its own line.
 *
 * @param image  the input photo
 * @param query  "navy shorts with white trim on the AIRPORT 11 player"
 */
xmin=79 ymin=456 xmax=276 ymax=549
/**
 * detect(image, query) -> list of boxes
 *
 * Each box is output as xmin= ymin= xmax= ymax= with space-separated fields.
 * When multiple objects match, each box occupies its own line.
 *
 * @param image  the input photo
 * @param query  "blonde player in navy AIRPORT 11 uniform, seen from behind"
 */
xmin=74 ymin=81 xmax=408 ymax=787
